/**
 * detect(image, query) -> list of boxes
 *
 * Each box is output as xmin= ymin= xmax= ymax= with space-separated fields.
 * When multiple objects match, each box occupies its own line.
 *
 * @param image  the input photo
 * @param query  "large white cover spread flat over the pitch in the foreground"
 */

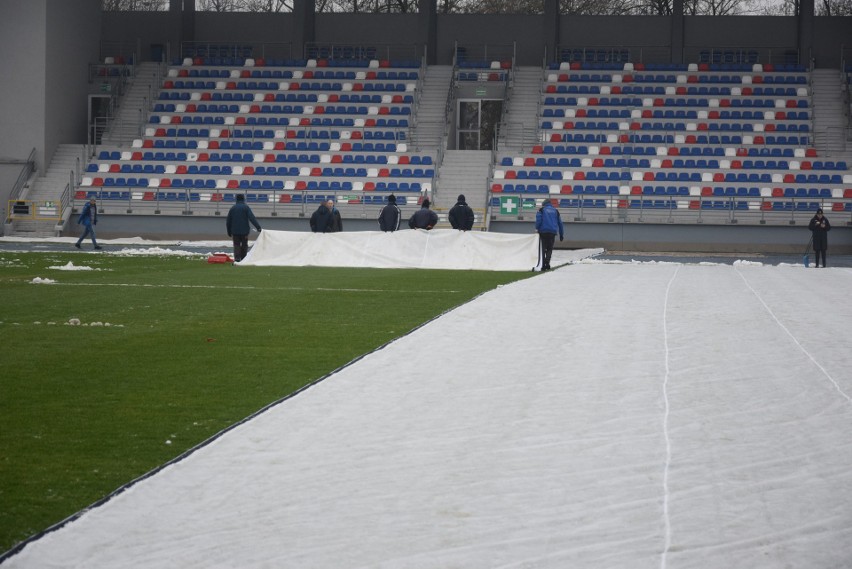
xmin=3 ymin=258 xmax=852 ymax=569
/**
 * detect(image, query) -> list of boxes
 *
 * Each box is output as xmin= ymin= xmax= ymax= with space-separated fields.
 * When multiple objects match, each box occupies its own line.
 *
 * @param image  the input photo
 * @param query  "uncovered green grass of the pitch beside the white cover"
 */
xmin=0 ymin=252 xmax=530 ymax=552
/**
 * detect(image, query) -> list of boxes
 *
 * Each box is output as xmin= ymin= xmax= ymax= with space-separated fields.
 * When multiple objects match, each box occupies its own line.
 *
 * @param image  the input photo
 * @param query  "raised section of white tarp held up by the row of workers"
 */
xmin=240 ymin=229 xmax=538 ymax=271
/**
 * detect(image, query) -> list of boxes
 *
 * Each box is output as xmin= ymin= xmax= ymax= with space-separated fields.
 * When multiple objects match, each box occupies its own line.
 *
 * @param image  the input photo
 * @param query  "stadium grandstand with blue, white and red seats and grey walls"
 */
xmin=0 ymin=0 xmax=852 ymax=252
